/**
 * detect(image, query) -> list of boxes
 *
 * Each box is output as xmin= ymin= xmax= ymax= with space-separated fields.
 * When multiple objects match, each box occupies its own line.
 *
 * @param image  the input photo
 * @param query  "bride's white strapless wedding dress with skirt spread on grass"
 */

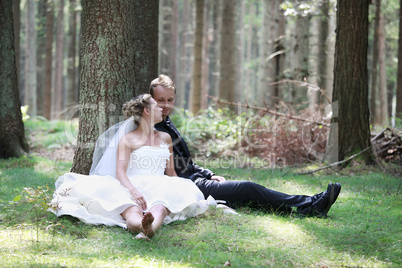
xmin=50 ymin=144 xmax=216 ymax=228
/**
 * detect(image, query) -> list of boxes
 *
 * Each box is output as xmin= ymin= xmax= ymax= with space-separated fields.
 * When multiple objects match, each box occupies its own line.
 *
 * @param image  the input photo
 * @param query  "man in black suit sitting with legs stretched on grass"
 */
xmin=150 ymin=75 xmax=341 ymax=216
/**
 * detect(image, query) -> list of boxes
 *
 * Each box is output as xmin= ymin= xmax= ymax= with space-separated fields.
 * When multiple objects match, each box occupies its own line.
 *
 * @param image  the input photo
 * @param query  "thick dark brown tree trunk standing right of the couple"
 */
xmin=326 ymin=0 xmax=373 ymax=164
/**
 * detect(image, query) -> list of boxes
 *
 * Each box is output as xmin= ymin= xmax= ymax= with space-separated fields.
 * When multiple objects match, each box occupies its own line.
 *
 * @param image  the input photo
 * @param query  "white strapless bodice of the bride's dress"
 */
xmin=127 ymin=144 xmax=170 ymax=177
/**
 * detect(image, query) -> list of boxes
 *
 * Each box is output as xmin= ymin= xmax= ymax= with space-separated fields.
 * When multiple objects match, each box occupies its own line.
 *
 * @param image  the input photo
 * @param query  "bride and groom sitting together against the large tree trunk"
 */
xmin=48 ymin=75 xmax=341 ymax=240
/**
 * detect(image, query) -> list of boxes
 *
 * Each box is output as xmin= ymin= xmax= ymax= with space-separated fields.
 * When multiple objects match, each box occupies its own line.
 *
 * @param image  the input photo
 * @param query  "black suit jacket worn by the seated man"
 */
xmin=155 ymin=117 xmax=215 ymax=181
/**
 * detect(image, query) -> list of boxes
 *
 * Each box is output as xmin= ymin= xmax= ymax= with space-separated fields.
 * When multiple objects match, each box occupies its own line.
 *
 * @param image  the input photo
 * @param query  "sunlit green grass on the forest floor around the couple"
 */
xmin=0 ymin=120 xmax=402 ymax=267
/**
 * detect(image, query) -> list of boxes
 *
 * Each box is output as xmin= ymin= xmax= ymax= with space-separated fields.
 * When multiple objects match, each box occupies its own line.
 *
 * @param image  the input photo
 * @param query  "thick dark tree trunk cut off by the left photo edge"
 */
xmin=0 ymin=1 xmax=29 ymax=158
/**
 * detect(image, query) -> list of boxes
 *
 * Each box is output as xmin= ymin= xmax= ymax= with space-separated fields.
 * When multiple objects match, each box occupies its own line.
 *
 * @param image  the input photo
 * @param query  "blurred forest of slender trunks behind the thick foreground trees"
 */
xmin=14 ymin=0 xmax=402 ymax=121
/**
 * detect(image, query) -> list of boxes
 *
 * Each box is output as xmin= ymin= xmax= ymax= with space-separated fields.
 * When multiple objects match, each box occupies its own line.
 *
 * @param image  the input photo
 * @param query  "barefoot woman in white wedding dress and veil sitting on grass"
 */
xmin=51 ymin=94 xmax=212 ymax=240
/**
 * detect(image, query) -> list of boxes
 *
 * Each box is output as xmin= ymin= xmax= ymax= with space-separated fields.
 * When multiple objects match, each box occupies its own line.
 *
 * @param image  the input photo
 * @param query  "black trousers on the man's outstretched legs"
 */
xmin=195 ymin=178 xmax=314 ymax=212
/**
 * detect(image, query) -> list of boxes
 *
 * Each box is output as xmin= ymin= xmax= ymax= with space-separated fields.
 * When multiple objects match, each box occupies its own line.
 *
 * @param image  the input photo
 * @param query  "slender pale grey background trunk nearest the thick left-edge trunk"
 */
xmin=24 ymin=0 xmax=37 ymax=116
